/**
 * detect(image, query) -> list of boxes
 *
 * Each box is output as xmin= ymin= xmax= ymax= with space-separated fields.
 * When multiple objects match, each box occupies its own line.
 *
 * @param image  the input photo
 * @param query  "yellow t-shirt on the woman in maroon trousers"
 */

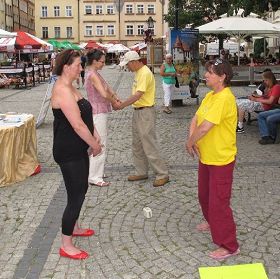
xmin=196 ymin=87 xmax=237 ymax=166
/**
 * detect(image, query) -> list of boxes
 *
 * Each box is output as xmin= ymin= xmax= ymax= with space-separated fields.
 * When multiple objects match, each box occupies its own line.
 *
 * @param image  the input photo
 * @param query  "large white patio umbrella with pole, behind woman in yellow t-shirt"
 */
xmin=198 ymin=16 xmax=280 ymax=65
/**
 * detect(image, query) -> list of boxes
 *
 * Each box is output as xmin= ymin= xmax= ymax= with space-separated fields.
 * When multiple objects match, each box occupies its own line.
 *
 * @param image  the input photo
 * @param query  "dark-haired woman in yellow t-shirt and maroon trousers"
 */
xmin=186 ymin=58 xmax=240 ymax=260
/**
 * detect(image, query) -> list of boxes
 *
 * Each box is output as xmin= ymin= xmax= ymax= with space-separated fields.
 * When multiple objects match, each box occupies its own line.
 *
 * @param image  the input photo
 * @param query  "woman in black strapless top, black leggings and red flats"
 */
xmin=51 ymin=49 xmax=101 ymax=259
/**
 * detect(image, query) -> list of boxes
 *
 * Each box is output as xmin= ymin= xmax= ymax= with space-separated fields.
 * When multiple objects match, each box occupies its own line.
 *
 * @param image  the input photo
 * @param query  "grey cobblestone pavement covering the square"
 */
xmin=0 ymin=67 xmax=280 ymax=279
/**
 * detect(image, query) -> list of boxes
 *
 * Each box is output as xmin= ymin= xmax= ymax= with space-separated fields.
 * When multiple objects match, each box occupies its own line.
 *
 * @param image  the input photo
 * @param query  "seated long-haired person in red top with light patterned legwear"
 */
xmin=236 ymin=72 xmax=280 ymax=134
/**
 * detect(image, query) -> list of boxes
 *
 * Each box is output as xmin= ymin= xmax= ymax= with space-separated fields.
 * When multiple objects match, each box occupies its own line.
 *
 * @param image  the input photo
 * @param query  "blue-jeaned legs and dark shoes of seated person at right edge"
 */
xmin=258 ymin=98 xmax=280 ymax=144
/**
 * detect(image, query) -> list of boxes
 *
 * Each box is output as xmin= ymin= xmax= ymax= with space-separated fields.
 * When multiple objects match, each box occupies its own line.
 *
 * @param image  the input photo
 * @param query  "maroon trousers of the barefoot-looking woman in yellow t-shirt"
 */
xmin=198 ymin=161 xmax=239 ymax=253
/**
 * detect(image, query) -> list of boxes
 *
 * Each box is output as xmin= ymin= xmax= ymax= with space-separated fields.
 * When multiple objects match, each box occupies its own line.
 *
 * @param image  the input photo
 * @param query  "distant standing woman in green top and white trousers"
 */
xmin=160 ymin=53 xmax=177 ymax=114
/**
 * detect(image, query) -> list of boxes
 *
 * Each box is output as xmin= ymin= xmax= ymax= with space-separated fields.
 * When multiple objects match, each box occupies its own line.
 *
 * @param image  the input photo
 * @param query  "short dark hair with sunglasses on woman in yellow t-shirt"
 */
xmin=205 ymin=58 xmax=233 ymax=86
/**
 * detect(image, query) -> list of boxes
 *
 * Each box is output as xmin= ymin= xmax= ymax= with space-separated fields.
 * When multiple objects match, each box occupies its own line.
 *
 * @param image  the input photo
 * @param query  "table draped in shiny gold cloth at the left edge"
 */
xmin=0 ymin=115 xmax=39 ymax=187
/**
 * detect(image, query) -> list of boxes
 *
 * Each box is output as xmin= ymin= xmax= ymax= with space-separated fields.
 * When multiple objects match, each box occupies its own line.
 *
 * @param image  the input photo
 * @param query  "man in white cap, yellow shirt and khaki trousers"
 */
xmin=119 ymin=51 xmax=169 ymax=187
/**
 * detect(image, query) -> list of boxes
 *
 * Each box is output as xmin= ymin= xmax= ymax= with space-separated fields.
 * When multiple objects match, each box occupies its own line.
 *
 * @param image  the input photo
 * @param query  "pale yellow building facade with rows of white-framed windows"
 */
xmin=35 ymin=0 xmax=166 ymax=46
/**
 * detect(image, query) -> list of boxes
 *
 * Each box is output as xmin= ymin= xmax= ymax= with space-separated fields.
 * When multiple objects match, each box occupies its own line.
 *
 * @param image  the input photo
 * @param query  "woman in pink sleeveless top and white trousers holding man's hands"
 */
xmin=85 ymin=49 xmax=120 ymax=187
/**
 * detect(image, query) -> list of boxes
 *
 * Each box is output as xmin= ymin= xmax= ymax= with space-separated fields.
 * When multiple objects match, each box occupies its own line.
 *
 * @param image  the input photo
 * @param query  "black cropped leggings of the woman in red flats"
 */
xmin=59 ymin=154 xmax=89 ymax=236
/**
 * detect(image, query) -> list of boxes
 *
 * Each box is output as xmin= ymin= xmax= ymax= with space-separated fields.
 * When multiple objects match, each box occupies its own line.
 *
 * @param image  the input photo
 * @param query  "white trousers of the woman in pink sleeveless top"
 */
xmin=88 ymin=113 xmax=108 ymax=183
